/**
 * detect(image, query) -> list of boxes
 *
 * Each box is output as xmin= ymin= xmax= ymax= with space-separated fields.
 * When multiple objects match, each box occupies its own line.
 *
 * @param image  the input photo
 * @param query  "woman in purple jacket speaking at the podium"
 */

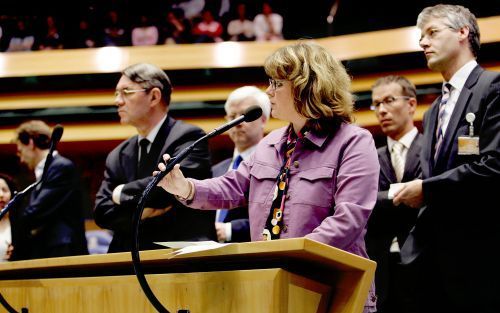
xmin=159 ymin=41 xmax=379 ymax=312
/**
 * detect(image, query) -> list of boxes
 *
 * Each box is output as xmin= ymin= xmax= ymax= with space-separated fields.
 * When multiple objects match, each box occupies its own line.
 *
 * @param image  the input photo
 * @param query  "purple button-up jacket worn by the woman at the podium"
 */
xmin=189 ymin=123 xmax=379 ymax=257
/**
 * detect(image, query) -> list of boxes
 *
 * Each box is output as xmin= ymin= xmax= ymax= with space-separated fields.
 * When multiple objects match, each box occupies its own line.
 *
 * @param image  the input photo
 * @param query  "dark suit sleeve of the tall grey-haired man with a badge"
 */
xmin=423 ymin=76 xmax=500 ymax=203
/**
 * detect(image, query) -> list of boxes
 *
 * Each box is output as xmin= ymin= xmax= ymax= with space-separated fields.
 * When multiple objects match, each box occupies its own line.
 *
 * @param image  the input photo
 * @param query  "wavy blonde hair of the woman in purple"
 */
xmin=264 ymin=41 xmax=354 ymax=132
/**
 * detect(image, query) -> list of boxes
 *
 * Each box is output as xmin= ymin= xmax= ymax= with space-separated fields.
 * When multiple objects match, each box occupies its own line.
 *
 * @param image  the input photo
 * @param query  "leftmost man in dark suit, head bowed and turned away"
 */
xmin=14 ymin=121 xmax=88 ymax=259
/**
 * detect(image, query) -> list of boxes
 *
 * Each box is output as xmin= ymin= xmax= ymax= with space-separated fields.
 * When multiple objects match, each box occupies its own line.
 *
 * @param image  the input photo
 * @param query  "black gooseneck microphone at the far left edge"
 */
xmin=0 ymin=125 xmax=64 ymax=313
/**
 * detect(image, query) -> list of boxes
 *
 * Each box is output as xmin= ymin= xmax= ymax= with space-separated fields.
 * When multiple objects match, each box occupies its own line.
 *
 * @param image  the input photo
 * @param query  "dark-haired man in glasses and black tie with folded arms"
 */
xmin=94 ymin=63 xmax=215 ymax=252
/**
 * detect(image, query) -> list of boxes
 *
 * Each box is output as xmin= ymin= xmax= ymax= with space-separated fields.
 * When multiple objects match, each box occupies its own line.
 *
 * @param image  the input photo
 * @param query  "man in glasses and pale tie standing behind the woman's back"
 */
xmin=365 ymin=76 xmax=422 ymax=313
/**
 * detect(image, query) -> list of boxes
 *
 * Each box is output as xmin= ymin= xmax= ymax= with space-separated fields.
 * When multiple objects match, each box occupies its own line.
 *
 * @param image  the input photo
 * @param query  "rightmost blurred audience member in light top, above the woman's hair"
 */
xmin=253 ymin=2 xmax=283 ymax=41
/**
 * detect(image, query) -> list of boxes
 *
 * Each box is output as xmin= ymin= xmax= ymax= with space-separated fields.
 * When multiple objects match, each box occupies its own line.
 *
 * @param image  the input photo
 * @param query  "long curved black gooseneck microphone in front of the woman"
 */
xmin=131 ymin=106 xmax=262 ymax=313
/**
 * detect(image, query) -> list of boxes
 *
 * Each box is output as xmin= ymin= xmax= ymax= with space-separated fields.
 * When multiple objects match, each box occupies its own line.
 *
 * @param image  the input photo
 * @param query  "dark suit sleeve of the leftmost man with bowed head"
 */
xmin=22 ymin=161 xmax=77 ymax=229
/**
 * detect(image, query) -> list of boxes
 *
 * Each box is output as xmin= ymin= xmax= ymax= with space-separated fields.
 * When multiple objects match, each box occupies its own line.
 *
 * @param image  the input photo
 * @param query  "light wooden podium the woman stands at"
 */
xmin=0 ymin=238 xmax=376 ymax=313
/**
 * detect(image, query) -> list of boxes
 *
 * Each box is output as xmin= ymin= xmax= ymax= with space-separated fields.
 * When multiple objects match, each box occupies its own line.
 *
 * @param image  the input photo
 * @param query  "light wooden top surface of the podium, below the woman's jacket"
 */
xmin=0 ymin=238 xmax=376 ymax=280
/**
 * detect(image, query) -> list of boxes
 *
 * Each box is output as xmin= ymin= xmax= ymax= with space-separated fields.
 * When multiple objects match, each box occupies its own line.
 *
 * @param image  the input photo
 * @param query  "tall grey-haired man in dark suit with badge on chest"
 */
xmin=394 ymin=5 xmax=500 ymax=313
